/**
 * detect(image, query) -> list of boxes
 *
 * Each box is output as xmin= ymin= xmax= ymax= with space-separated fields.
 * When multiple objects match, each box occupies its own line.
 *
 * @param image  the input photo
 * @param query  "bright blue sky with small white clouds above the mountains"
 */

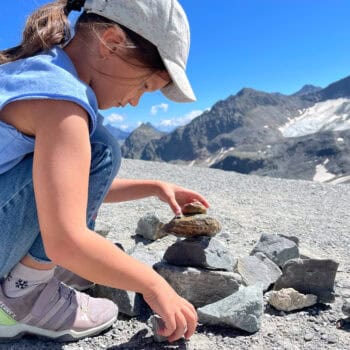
xmin=0 ymin=0 xmax=350 ymax=129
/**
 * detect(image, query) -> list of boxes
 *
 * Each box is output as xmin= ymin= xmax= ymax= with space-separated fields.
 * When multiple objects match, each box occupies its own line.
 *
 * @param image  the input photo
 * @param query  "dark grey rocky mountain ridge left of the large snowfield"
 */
xmin=141 ymin=89 xmax=311 ymax=162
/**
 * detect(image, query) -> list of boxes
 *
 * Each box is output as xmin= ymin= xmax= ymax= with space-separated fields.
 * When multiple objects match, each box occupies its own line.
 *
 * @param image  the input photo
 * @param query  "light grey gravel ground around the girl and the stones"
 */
xmin=0 ymin=159 xmax=350 ymax=350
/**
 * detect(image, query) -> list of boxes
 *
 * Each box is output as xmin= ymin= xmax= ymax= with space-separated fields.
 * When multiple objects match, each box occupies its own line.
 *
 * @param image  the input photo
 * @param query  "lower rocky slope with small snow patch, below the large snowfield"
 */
xmin=210 ymin=130 xmax=350 ymax=182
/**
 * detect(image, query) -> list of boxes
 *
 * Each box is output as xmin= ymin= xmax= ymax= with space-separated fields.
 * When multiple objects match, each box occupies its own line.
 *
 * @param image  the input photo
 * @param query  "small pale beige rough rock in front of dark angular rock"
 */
xmin=268 ymin=288 xmax=317 ymax=311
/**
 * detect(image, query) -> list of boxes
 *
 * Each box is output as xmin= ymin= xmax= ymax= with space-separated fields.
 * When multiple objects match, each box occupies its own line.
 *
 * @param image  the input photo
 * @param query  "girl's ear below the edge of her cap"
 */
xmin=99 ymin=27 xmax=126 ymax=59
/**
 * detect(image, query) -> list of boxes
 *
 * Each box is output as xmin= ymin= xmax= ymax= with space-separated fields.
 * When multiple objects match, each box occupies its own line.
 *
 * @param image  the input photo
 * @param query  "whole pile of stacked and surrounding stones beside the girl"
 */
xmin=94 ymin=202 xmax=340 ymax=341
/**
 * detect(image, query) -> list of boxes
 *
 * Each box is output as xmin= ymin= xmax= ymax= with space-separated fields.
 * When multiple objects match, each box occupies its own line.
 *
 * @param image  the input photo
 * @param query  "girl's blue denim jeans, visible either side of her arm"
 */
xmin=0 ymin=123 xmax=121 ymax=278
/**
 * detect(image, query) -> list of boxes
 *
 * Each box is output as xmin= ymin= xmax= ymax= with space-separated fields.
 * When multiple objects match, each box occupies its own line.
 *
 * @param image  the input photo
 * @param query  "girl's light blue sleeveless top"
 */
xmin=0 ymin=47 xmax=102 ymax=174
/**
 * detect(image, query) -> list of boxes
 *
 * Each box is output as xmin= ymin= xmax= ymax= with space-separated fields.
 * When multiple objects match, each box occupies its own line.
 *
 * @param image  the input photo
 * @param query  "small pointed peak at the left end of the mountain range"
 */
xmin=122 ymin=123 xmax=166 ymax=159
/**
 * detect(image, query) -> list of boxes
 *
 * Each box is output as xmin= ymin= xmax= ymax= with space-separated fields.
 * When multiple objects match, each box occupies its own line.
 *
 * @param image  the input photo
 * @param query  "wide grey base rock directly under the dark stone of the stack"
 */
xmin=153 ymin=262 xmax=242 ymax=307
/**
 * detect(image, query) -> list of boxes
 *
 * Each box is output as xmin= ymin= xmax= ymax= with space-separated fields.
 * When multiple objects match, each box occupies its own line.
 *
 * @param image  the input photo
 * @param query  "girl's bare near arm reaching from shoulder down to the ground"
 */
xmin=30 ymin=100 xmax=197 ymax=341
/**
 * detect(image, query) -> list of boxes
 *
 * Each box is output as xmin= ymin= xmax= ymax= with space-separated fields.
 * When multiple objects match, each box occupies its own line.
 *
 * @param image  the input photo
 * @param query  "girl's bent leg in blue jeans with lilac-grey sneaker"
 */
xmin=0 ymin=121 xmax=120 ymax=341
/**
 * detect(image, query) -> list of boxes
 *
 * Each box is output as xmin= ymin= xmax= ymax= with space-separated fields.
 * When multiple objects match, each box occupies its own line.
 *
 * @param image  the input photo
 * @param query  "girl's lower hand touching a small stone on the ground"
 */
xmin=143 ymin=278 xmax=198 ymax=342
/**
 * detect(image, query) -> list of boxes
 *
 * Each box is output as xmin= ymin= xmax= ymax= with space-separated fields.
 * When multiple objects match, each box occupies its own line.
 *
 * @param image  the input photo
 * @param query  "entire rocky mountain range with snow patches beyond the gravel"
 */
xmin=119 ymin=77 xmax=350 ymax=181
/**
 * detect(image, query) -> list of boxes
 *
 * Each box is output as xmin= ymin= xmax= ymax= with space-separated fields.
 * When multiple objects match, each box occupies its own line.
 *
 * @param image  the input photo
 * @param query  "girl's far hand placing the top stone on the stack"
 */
xmin=157 ymin=182 xmax=209 ymax=215
